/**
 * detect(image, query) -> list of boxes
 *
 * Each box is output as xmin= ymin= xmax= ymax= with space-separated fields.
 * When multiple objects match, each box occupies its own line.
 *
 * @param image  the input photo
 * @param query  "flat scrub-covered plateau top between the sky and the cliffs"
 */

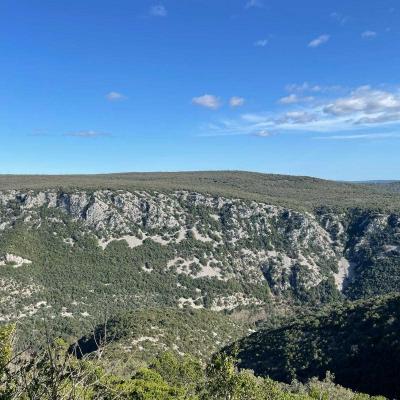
xmin=0 ymin=171 xmax=400 ymax=210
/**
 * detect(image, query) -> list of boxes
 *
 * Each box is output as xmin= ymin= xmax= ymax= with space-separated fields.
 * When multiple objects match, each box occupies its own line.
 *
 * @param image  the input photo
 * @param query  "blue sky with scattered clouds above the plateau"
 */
xmin=0 ymin=0 xmax=400 ymax=180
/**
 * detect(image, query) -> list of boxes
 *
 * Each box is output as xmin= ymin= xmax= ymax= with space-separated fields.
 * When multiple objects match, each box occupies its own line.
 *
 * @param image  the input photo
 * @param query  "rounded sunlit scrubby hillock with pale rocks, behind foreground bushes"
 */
xmin=71 ymin=308 xmax=251 ymax=374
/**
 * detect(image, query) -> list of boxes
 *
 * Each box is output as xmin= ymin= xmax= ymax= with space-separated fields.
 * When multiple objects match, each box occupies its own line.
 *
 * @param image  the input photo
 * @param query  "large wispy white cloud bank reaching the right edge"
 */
xmin=202 ymin=86 xmax=400 ymax=135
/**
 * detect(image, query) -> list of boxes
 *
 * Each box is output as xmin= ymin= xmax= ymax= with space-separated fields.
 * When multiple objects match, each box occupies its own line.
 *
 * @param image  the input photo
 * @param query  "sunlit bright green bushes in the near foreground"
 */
xmin=0 ymin=326 xmax=384 ymax=400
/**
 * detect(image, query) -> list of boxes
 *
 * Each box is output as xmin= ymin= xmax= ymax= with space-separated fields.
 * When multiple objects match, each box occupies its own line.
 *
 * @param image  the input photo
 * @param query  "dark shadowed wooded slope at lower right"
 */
xmin=230 ymin=295 xmax=400 ymax=398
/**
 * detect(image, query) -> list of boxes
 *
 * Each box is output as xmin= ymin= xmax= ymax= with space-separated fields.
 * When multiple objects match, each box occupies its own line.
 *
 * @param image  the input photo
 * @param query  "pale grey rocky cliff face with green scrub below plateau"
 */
xmin=0 ymin=190 xmax=400 ymax=320
